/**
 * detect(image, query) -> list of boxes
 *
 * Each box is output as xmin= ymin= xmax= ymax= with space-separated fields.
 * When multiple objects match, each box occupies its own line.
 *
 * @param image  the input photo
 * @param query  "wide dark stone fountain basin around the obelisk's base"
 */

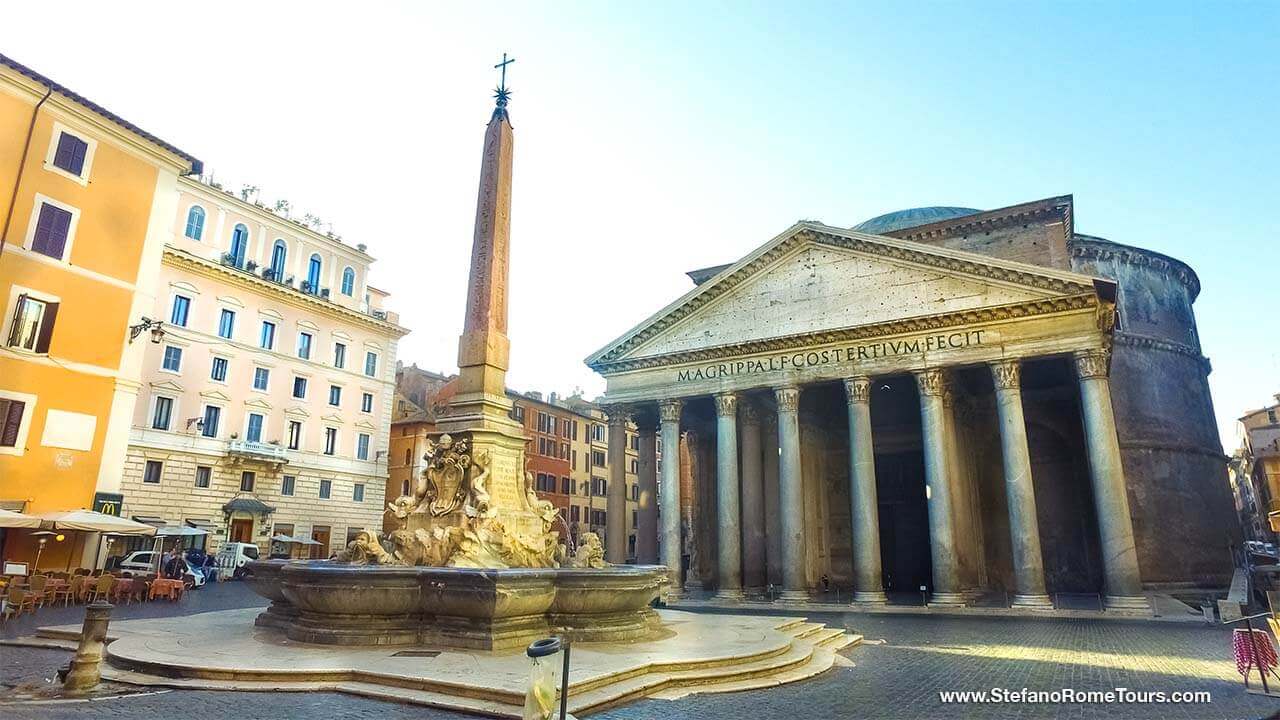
xmin=246 ymin=560 xmax=667 ymax=650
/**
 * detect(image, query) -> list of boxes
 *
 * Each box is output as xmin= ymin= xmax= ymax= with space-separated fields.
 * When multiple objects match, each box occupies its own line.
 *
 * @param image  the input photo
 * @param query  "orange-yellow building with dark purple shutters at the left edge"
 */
xmin=0 ymin=55 xmax=200 ymax=566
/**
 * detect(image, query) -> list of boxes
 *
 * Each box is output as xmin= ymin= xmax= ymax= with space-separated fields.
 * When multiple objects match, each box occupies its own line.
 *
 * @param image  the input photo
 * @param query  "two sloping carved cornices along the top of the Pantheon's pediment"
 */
xmin=586 ymin=222 xmax=1098 ymax=369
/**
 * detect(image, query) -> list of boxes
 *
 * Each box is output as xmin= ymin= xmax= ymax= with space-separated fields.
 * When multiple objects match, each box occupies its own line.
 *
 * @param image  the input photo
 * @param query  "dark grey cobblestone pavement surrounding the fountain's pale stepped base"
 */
xmin=0 ymin=583 xmax=1280 ymax=720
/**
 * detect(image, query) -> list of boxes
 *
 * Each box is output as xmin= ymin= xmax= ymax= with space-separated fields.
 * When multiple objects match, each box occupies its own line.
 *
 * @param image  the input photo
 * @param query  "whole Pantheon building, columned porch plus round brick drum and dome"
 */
xmin=586 ymin=196 xmax=1239 ymax=611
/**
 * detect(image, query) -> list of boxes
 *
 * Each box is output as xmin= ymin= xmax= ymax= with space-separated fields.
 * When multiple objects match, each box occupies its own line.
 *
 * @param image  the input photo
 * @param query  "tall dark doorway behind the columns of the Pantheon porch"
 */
xmin=876 ymin=451 xmax=933 ymax=592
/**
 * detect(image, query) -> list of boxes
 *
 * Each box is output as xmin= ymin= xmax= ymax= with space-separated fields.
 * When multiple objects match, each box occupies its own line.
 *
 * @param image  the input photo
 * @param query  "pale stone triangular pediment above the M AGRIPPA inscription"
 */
xmin=588 ymin=223 xmax=1096 ymax=369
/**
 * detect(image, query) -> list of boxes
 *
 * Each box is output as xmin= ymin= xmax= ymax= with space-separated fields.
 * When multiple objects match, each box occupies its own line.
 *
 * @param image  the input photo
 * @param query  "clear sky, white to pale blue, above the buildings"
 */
xmin=0 ymin=3 xmax=1280 ymax=447
